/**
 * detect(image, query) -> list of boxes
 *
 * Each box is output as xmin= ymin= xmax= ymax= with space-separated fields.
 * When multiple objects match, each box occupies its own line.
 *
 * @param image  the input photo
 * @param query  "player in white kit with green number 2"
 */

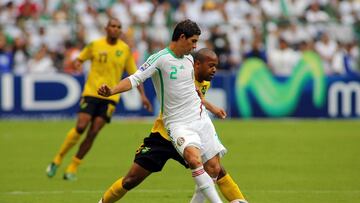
xmin=98 ymin=20 xmax=226 ymax=203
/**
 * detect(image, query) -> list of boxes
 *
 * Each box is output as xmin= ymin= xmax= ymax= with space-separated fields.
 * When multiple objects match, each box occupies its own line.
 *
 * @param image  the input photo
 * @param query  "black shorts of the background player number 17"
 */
xmin=79 ymin=96 xmax=116 ymax=123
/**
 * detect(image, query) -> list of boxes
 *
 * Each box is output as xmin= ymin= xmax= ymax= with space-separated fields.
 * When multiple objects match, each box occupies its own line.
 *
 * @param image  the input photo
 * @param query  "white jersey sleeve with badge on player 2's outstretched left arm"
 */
xmin=128 ymin=54 xmax=161 ymax=87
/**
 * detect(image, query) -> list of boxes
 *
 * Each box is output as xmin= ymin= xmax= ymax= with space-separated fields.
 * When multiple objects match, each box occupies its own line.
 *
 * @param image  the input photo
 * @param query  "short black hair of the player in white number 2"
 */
xmin=171 ymin=19 xmax=201 ymax=41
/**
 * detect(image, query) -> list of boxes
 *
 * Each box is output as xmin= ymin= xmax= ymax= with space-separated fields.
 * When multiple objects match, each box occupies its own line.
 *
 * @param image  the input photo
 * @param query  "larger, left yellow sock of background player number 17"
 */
xmin=53 ymin=128 xmax=80 ymax=165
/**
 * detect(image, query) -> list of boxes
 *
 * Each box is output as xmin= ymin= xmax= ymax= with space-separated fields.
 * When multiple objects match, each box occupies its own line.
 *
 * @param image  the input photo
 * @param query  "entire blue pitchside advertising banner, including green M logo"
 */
xmin=0 ymin=52 xmax=360 ymax=118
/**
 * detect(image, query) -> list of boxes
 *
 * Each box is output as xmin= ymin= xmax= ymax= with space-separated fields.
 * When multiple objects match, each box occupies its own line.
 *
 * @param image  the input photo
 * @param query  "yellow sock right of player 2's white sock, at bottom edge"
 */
xmin=216 ymin=174 xmax=245 ymax=202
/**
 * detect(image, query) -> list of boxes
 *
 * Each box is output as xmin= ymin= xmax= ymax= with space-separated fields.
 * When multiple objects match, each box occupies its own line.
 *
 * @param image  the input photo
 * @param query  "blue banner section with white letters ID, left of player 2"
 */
xmin=0 ymin=73 xmax=156 ymax=118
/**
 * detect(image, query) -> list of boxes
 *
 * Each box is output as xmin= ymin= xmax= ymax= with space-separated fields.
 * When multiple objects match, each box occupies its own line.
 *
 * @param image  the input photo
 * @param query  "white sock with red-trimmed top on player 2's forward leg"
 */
xmin=191 ymin=166 xmax=222 ymax=203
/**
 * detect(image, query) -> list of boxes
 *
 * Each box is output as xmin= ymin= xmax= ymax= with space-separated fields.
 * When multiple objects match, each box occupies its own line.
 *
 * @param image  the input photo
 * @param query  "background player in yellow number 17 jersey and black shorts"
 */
xmin=46 ymin=18 xmax=152 ymax=180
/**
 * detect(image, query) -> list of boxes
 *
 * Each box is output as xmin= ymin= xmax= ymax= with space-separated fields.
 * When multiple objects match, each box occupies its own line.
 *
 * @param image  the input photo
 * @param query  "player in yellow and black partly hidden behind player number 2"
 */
xmin=99 ymin=48 xmax=247 ymax=203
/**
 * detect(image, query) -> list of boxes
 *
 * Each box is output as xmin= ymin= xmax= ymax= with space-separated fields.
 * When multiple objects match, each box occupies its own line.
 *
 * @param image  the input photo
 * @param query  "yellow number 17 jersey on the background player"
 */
xmin=78 ymin=37 xmax=137 ymax=103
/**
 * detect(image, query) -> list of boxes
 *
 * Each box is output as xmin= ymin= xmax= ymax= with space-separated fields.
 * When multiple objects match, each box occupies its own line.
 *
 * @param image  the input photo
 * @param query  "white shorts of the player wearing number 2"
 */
xmin=168 ymin=115 xmax=227 ymax=163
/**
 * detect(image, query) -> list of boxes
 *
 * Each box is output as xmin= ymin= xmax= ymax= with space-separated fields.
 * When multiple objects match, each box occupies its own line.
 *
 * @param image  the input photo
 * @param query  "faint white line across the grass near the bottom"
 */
xmin=0 ymin=189 xmax=360 ymax=196
